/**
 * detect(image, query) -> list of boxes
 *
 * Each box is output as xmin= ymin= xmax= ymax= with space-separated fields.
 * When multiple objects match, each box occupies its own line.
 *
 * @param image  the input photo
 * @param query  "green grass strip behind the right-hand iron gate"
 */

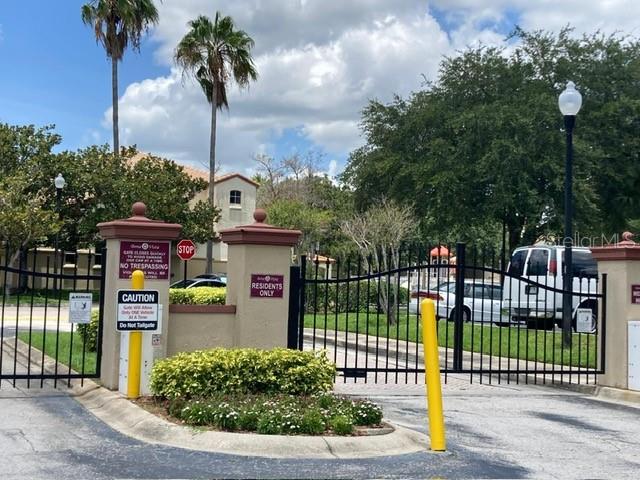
xmin=304 ymin=312 xmax=597 ymax=368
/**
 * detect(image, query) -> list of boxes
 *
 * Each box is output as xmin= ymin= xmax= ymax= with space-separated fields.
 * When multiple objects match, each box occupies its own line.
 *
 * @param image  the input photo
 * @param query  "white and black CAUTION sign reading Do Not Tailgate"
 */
xmin=116 ymin=290 xmax=159 ymax=332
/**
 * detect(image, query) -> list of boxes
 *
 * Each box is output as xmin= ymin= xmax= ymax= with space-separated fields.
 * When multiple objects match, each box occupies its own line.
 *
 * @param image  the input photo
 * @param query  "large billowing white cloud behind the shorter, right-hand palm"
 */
xmin=116 ymin=1 xmax=456 ymax=171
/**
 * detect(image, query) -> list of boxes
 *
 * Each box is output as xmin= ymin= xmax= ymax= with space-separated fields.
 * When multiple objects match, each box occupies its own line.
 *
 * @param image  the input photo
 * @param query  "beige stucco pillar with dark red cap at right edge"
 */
xmin=592 ymin=232 xmax=640 ymax=389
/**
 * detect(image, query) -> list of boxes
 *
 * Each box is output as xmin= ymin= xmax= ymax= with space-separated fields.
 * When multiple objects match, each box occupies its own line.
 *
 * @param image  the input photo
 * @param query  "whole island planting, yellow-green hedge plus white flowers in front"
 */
xmin=150 ymin=348 xmax=386 ymax=435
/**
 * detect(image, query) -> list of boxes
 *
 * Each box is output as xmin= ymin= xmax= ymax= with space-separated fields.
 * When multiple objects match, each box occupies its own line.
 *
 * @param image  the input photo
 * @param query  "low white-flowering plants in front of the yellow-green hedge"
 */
xmin=166 ymin=393 xmax=382 ymax=435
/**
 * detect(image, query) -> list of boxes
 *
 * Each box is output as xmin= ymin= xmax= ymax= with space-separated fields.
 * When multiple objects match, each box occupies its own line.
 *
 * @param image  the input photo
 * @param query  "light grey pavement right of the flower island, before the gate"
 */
xmin=337 ymin=375 xmax=640 ymax=478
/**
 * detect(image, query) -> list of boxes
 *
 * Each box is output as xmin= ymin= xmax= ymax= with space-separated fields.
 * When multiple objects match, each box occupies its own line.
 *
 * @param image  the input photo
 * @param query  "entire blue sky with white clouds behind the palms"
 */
xmin=0 ymin=0 xmax=640 ymax=174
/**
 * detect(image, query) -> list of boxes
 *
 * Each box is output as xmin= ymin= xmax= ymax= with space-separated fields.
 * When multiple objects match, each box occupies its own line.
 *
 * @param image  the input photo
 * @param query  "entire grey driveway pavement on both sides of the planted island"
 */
xmin=0 ymin=370 xmax=640 ymax=479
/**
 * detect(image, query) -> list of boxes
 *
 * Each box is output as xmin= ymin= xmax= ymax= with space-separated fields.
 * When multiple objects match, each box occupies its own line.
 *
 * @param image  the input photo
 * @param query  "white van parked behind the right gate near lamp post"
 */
xmin=500 ymin=245 xmax=598 ymax=332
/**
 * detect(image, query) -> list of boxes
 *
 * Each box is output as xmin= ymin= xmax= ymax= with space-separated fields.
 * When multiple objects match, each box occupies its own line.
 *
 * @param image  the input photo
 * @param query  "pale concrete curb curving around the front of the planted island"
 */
xmin=5 ymin=340 xmax=429 ymax=459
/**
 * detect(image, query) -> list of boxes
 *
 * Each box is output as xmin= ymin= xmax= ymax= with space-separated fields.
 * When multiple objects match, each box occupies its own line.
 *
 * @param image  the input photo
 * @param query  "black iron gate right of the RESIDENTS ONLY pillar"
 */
xmin=289 ymin=244 xmax=606 ymax=383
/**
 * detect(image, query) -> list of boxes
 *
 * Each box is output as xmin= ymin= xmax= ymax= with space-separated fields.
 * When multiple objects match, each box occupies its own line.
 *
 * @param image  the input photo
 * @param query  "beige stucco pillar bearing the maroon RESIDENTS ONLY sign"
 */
xmin=220 ymin=209 xmax=302 ymax=349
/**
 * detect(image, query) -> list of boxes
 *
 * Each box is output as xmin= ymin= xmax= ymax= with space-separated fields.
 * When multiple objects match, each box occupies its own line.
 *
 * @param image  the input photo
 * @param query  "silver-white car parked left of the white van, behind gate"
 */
xmin=409 ymin=280 xmax=502 ymax=323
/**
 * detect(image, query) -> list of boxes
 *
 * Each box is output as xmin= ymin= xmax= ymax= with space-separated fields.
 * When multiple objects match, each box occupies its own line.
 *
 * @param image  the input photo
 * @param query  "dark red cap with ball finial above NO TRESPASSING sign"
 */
xmin=98 ymin=202 xmax=182 ymax=240
